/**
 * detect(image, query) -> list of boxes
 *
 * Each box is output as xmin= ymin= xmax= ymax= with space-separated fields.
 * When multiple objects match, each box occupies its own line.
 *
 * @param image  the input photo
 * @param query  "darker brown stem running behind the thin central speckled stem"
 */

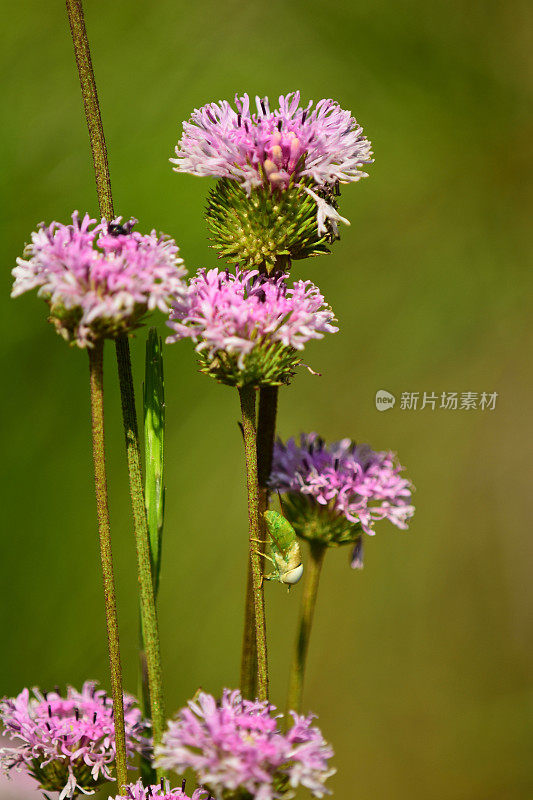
xmin=241 ymin=386 xmax=278 ymax=699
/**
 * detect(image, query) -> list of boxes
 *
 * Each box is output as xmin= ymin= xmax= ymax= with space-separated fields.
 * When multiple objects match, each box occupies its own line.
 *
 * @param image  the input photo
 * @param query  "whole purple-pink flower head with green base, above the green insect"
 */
xmin=270 ymin=433 xmax=414 ymax=552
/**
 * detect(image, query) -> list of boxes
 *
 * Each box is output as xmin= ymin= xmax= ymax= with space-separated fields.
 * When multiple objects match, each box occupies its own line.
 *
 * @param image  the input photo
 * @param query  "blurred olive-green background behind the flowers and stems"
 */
xmin=0 ymin=0 xmax=533 ymax=800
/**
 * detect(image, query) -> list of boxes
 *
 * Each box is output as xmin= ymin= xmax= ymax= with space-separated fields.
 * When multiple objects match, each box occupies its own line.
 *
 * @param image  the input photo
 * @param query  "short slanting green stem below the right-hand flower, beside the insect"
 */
xmin=287 ymin=542 xmax=327 ymax=713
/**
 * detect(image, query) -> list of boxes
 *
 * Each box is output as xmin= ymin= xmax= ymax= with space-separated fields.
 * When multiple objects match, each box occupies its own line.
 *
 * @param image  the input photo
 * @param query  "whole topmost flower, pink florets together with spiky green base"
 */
xmin=171 ymin=92 xmax=372 ymax=272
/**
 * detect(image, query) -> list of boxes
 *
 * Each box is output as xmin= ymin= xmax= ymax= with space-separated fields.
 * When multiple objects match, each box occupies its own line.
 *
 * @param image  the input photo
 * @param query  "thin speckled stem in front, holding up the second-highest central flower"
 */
xmin=239 ymin=386 xmax=268 ymax=700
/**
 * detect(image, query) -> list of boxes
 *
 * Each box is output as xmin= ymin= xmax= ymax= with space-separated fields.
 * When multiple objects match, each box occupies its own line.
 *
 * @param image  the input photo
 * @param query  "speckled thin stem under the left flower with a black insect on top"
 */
xmin=88 ymin=339 xmax=127 ymax=794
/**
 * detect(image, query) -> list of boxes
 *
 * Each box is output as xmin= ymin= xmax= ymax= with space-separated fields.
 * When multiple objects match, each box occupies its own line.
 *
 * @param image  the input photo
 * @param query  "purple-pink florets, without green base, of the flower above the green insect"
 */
xmin=270 ymin=433 xmax=414 ymax=534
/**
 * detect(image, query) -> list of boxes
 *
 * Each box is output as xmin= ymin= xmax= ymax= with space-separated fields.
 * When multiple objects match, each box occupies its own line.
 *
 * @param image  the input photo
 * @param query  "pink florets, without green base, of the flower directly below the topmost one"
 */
xmin=167 ymin=269 xmax=338 ymax=368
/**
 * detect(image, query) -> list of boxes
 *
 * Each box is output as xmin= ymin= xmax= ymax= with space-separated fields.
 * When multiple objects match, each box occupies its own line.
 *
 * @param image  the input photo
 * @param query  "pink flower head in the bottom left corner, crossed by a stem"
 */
xmin=0 ymin=681 xmax=146 ymax=800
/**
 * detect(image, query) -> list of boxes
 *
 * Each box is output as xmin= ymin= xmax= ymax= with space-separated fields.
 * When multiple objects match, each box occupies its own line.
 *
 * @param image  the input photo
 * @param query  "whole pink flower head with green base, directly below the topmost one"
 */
xmin=167 ymin=269 xmax=338 ymax=386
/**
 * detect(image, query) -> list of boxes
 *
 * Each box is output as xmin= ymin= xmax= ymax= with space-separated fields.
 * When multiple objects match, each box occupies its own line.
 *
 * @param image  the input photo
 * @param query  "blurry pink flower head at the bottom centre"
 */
xmin=156 ymin=689 xmax=334 ymax=800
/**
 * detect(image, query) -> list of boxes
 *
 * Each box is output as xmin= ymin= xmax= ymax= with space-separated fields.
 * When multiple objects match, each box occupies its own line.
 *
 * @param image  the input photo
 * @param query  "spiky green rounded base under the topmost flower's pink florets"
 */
xmin=206 ymin=178 xmax=339 ymax=274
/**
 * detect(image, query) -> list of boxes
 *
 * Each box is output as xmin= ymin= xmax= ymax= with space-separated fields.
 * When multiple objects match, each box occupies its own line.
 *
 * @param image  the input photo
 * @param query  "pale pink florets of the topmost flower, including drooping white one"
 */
xmin=170 ymin=92 xmax=372 ymax=234
